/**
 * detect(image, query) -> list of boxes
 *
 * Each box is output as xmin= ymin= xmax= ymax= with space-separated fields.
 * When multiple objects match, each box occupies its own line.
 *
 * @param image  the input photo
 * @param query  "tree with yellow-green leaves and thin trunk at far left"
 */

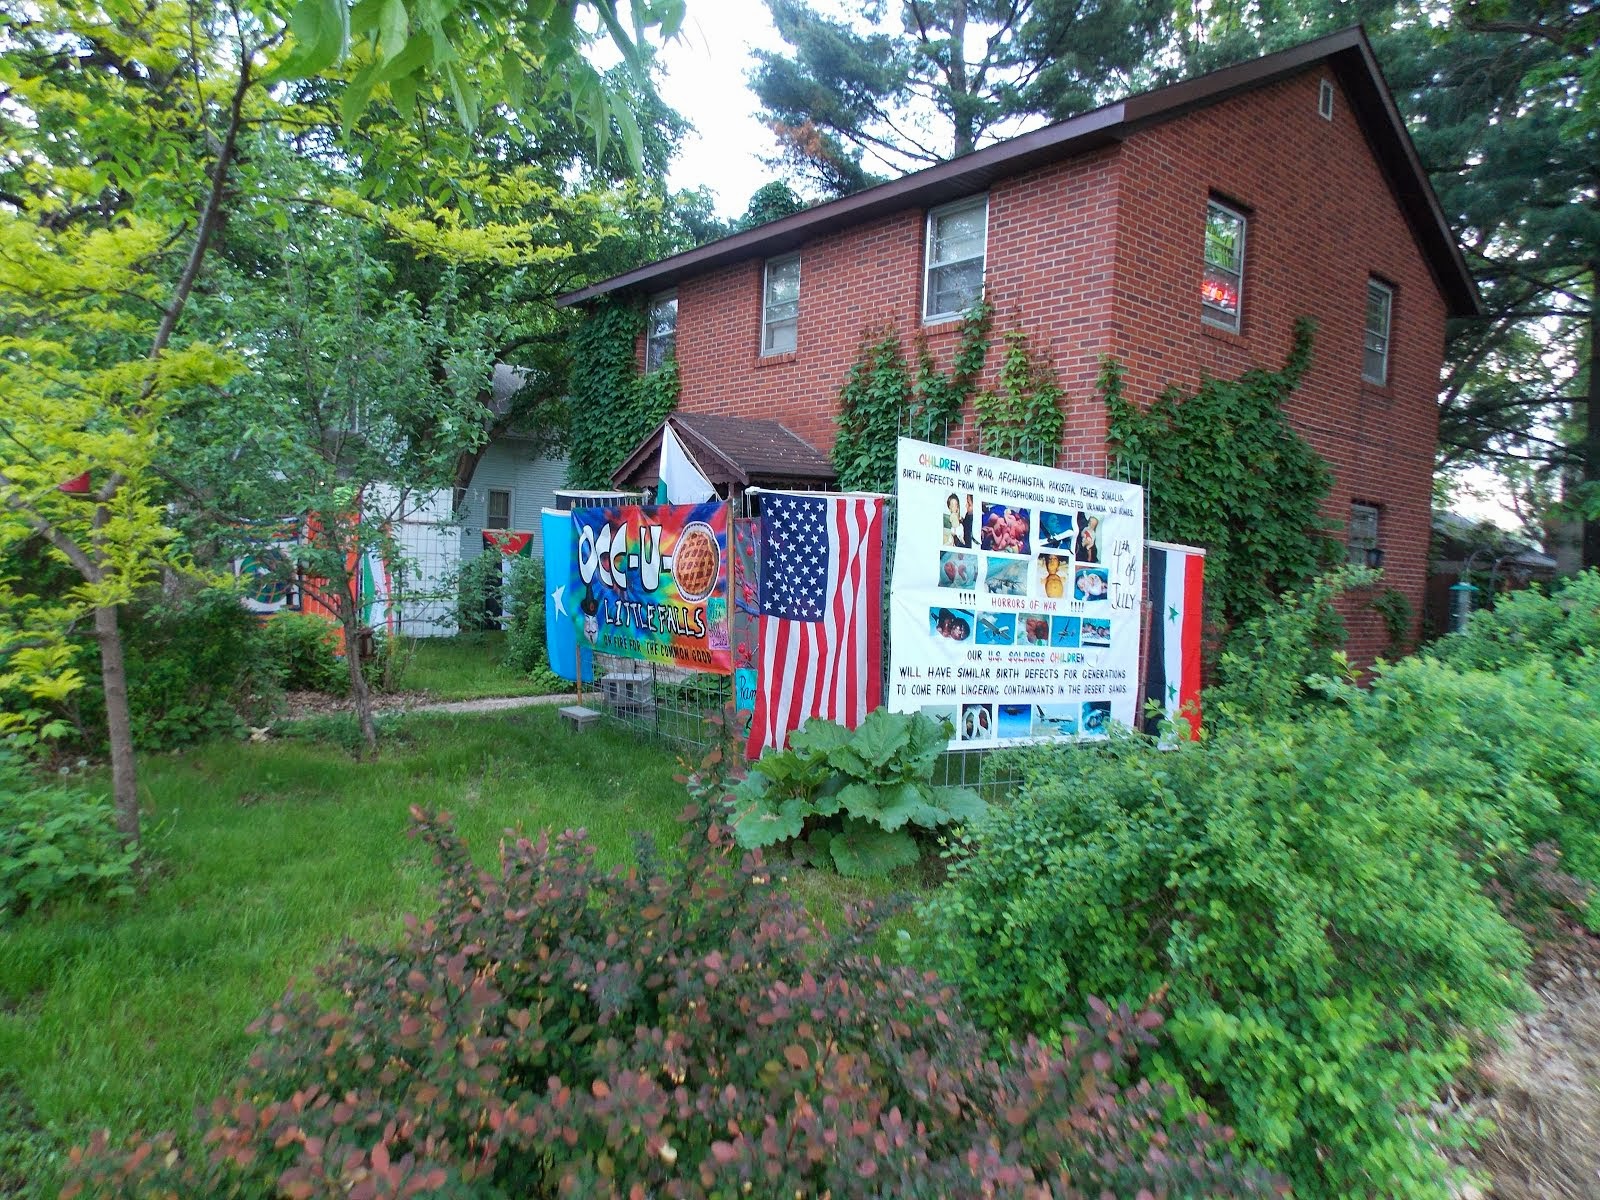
xmin=0 ymin=0 xmax=683 ymax=840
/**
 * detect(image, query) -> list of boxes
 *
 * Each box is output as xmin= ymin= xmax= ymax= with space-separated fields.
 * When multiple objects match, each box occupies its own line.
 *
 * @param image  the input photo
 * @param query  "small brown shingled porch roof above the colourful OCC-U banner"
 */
xmin=611 ymin=413 xmax=835 ymax=488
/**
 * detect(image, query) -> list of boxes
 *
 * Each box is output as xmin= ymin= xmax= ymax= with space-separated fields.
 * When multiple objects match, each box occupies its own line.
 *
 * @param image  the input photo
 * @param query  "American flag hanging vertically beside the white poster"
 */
xmin=747 ymin=493 xmax=883 ymax=758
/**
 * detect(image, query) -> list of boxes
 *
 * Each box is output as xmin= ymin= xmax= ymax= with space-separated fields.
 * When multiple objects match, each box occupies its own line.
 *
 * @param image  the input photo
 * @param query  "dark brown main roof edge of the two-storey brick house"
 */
xmin=557 ymin=26 xmax=1482 ymax=317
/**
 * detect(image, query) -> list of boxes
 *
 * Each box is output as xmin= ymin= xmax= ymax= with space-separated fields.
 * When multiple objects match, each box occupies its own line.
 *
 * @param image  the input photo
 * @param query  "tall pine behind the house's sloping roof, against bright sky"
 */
xmin=750 ymin=0 xmax=1168 ymax=195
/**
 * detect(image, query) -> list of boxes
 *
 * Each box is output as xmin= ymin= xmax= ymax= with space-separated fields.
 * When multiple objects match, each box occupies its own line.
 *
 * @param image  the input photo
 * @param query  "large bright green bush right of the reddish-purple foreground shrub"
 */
xmin=926 ymin=713 xmax=1530 ymax=1198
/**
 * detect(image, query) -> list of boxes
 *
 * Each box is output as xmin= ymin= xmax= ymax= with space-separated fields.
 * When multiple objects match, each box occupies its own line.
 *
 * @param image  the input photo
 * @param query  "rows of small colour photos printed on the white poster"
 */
xmin=922 ymin=490 xmax=1112 ymax=742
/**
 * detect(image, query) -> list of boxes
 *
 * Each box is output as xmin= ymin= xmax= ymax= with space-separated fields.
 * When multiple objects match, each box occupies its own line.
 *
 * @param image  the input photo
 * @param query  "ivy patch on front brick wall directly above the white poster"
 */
xmin=834 ymin=301 xmax=1066 ymax=491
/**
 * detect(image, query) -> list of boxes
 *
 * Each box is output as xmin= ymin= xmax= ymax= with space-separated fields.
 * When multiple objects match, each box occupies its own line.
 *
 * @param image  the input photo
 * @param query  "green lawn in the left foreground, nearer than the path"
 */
xmin=0 ymin=709 xmax=685 ymax=1190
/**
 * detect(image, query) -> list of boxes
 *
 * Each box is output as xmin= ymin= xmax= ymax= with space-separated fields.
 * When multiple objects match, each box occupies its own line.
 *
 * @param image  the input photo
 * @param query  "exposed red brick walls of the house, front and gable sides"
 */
xmin=665 ymin=69 xmax=1445 ymax=661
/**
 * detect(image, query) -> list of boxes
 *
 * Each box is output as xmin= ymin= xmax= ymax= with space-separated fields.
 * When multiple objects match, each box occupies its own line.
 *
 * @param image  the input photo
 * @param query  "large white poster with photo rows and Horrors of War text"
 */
xmin=888 ymin=438 xmax=1144 ymax=749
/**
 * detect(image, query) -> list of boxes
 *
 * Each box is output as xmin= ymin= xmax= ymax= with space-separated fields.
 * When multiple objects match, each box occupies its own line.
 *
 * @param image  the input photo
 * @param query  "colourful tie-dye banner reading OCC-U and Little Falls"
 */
xmin=566 ymin=502 xmax=733 ymax=675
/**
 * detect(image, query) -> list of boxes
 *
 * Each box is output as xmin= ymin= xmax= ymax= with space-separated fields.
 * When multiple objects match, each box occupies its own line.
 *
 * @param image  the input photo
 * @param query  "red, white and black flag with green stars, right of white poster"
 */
xmin=1142 ymin=542 xmax=1205 ymax=739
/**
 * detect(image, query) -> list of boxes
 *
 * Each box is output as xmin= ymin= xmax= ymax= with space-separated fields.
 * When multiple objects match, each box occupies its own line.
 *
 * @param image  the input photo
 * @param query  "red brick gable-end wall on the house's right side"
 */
xmin=1117 ymin=70 xmax=1445 ymax=662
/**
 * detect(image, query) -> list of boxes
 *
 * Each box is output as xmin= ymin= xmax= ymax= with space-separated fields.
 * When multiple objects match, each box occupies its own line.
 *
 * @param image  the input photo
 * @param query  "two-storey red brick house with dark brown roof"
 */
xmin=562 ymin=29 xmax=1478 ymax=659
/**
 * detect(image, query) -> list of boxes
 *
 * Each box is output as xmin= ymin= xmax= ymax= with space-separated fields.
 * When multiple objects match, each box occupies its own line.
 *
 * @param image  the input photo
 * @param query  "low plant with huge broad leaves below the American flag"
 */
xmin=730 ymin=709 xmax=987 ymax=875
